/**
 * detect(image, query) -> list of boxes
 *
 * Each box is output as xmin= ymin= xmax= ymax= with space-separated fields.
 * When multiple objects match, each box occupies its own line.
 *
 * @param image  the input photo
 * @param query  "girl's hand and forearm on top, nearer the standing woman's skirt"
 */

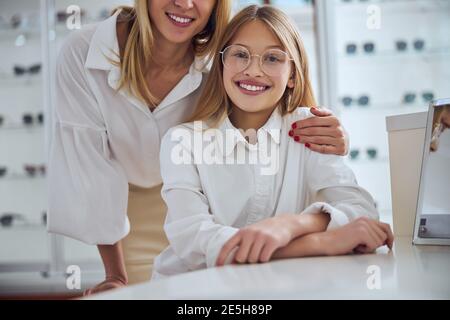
xmin=216 ymin=215 xmax=298 ymax=266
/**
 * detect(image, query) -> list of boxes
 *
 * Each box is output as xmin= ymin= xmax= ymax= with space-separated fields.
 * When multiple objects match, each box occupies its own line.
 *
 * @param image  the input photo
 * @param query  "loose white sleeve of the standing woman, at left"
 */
xmin=48 ymin=34 xmax=129 ymax=244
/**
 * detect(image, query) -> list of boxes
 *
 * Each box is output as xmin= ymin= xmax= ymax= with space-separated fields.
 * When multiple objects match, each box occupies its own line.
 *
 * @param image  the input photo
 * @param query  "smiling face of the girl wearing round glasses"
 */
xmin=222 ymin=20 xmax=294 ymax=113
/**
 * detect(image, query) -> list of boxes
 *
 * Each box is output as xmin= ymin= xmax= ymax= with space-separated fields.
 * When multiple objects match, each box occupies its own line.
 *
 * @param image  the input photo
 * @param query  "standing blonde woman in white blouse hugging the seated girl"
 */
xmin=48 ymin=0 xmax=347 ymax=294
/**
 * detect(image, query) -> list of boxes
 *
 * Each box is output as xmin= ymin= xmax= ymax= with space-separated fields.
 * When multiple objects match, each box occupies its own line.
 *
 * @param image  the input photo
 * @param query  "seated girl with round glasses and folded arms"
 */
xmin=153 ymin=6 xmax=393 ymax=279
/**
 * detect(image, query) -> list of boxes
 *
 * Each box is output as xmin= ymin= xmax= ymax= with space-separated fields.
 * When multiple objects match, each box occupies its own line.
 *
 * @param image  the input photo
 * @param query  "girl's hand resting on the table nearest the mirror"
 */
xmin=322 ymin=217 xmax=394 ymax=256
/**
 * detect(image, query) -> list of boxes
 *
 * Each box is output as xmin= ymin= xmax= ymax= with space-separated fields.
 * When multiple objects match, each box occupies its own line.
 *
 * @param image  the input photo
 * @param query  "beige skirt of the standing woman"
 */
xmin=122 ymin=185 xmax=168 ymax=284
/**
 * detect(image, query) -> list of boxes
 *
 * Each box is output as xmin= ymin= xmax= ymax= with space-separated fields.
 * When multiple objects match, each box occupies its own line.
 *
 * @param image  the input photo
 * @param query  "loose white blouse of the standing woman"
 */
xmin=48 ymin=14 xmax=205 ymax=244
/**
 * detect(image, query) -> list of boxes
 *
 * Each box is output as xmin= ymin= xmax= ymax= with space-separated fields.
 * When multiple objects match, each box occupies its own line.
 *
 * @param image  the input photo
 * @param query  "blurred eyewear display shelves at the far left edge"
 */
xmin=0 ymin=0 xmax=51 ymax=272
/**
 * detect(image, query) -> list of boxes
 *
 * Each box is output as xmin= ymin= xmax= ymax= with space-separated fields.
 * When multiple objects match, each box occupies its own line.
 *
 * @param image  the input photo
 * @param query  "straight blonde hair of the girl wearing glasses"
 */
xmin=189 ymin=5 xmax=316 ymax=126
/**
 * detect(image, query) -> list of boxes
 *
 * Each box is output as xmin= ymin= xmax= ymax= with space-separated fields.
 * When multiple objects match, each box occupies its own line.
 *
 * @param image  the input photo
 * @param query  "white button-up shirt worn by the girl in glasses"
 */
xmin=153 ymin=108 xmax=378 ymax=279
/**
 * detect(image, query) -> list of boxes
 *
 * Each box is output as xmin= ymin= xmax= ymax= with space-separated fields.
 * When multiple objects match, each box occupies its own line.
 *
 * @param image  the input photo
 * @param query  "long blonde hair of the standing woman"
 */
xmin=113 ymin=0 xmax=232 ymax=106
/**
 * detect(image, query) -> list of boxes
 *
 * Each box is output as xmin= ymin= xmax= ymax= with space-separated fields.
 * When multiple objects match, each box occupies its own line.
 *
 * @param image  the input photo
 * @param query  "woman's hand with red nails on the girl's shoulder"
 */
xmin=289 ymin=108 xmax=349 ymax=156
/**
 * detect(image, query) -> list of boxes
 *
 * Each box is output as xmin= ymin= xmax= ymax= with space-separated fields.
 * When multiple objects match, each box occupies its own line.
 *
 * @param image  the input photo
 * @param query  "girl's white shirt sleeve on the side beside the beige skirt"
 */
xmin=161 ymin=128 xmax=238 ymax=270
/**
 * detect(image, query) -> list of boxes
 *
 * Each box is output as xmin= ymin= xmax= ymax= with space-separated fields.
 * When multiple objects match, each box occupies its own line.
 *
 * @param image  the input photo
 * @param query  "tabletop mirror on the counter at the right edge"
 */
xmin=413 ymin=99 xmax=450 ymax=245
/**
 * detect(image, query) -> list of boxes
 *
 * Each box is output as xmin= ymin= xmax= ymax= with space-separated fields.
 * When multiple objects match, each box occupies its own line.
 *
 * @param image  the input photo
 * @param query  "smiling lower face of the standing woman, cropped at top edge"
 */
xmin=148 ymin=0 xmax=216 ymax=44
